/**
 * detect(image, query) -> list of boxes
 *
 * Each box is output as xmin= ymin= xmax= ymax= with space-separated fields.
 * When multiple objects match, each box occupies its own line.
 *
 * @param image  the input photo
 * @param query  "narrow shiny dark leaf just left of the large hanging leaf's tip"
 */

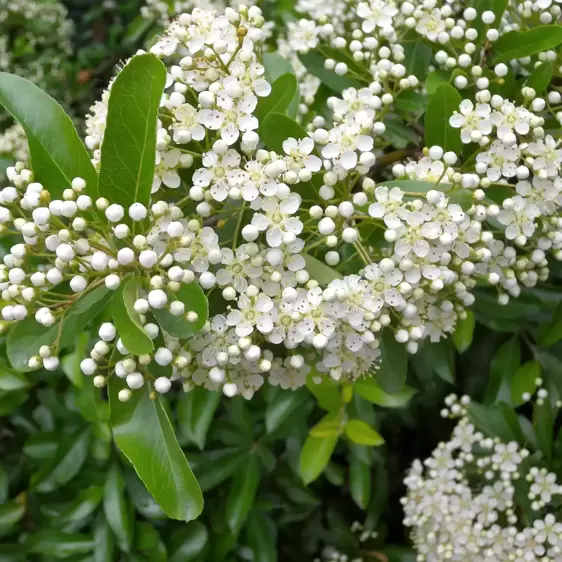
xmin=103 ymin=462 xmax=133 ymax=552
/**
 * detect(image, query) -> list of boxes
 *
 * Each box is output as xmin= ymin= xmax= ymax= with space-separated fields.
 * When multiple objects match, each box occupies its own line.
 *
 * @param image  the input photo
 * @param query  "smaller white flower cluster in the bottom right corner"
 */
xmin=402 ymin=390 xmax=562 ymax=562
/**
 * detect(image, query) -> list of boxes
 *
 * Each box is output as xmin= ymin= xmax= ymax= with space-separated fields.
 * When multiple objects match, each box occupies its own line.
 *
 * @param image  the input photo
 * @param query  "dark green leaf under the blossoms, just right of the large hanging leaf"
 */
xmin=178 ymin=386 xmax=221 ymax=450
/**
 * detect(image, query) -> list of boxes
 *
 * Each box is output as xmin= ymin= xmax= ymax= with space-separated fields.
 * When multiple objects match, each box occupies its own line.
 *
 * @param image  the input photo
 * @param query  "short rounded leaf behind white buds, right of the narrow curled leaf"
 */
xmin=151 ymin=283 xmax=209 ymax=336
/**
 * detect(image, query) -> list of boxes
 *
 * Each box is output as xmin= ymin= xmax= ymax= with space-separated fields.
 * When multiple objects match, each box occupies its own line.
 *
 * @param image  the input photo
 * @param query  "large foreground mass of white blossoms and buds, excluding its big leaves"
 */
xmin=3 ymin=0 xmax=562 ymax=398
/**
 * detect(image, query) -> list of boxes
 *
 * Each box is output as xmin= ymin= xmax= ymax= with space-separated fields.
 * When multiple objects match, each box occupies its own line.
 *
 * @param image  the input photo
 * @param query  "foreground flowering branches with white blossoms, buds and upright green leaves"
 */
xmin=0 ymin=0 xmax=562 ymax=520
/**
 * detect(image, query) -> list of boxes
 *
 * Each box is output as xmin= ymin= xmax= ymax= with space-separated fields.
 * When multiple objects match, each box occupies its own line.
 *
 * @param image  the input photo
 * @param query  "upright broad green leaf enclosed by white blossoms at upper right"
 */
xmin=424 ymin=84 xmax=462 ymax=154
